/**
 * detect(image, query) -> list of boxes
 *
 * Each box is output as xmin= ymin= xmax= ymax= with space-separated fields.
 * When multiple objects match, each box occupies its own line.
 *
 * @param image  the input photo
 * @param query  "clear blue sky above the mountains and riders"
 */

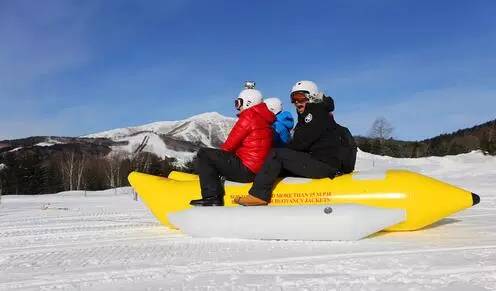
xmin=0 ymin=0 xmax=496 ymax=140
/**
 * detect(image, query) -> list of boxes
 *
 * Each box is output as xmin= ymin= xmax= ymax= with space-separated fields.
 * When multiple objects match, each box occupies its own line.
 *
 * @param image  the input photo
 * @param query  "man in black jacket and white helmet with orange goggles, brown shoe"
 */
xmin=236 ymin=81 xmax=356 ymax=206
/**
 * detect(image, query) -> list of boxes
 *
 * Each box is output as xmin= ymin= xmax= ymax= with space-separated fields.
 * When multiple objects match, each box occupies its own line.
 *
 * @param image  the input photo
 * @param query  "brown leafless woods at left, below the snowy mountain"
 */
xmin=0 ymin=147 xmax=173 ymax=194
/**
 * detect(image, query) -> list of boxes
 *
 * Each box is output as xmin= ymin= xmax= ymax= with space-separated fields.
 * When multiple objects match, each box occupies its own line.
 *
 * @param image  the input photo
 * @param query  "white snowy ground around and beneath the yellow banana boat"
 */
xmin=0 ymin=152 xmax=496 ymax=290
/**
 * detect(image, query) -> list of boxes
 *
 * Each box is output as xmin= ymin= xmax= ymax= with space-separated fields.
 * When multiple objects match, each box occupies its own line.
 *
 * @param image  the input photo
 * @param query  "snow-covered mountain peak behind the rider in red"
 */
xmin=84 ymin=112 xmax=235 ymax=164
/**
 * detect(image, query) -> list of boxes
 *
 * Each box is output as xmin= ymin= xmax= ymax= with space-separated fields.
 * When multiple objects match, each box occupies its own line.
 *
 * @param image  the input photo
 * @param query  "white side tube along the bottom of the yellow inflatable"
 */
xmin=169 ymin=204 xmax=406 ymax=240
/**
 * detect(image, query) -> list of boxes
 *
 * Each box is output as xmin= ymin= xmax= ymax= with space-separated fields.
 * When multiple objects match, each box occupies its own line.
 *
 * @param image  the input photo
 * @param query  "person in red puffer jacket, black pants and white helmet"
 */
xmin=190 ymin=85 xmax=275 ymax=206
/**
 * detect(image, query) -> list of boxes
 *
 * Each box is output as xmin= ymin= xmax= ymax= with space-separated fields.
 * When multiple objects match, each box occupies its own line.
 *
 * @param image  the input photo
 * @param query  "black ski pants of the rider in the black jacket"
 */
xmin=249 ymin=148 xmax=338 ymax=202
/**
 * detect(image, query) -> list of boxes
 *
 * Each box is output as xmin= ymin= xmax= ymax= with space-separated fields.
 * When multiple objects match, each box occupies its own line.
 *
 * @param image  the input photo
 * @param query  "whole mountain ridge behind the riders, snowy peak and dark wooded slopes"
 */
xmin=0 ymin=113 xmax=496 ymax=194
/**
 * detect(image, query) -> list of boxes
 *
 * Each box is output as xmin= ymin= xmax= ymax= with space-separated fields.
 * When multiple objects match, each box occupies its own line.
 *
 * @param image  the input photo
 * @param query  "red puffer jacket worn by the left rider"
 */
xmin=221 ymin=103 xmax=276 ymax=174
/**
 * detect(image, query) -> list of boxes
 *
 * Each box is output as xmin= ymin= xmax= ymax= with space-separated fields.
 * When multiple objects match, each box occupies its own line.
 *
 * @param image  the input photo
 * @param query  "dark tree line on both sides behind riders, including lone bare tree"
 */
xmin=0 ymin=118 xmax=496 ymax=194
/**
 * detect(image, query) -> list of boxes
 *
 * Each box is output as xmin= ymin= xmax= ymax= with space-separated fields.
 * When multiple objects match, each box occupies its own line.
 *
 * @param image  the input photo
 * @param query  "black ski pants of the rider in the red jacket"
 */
xmin=196 ymin=148 xmax=255 ymax=198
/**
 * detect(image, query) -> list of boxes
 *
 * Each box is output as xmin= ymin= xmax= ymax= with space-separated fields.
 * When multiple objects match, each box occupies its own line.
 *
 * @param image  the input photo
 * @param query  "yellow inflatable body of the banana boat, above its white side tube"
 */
xmin=129 ymin=170 xmax=480 ymax=231
